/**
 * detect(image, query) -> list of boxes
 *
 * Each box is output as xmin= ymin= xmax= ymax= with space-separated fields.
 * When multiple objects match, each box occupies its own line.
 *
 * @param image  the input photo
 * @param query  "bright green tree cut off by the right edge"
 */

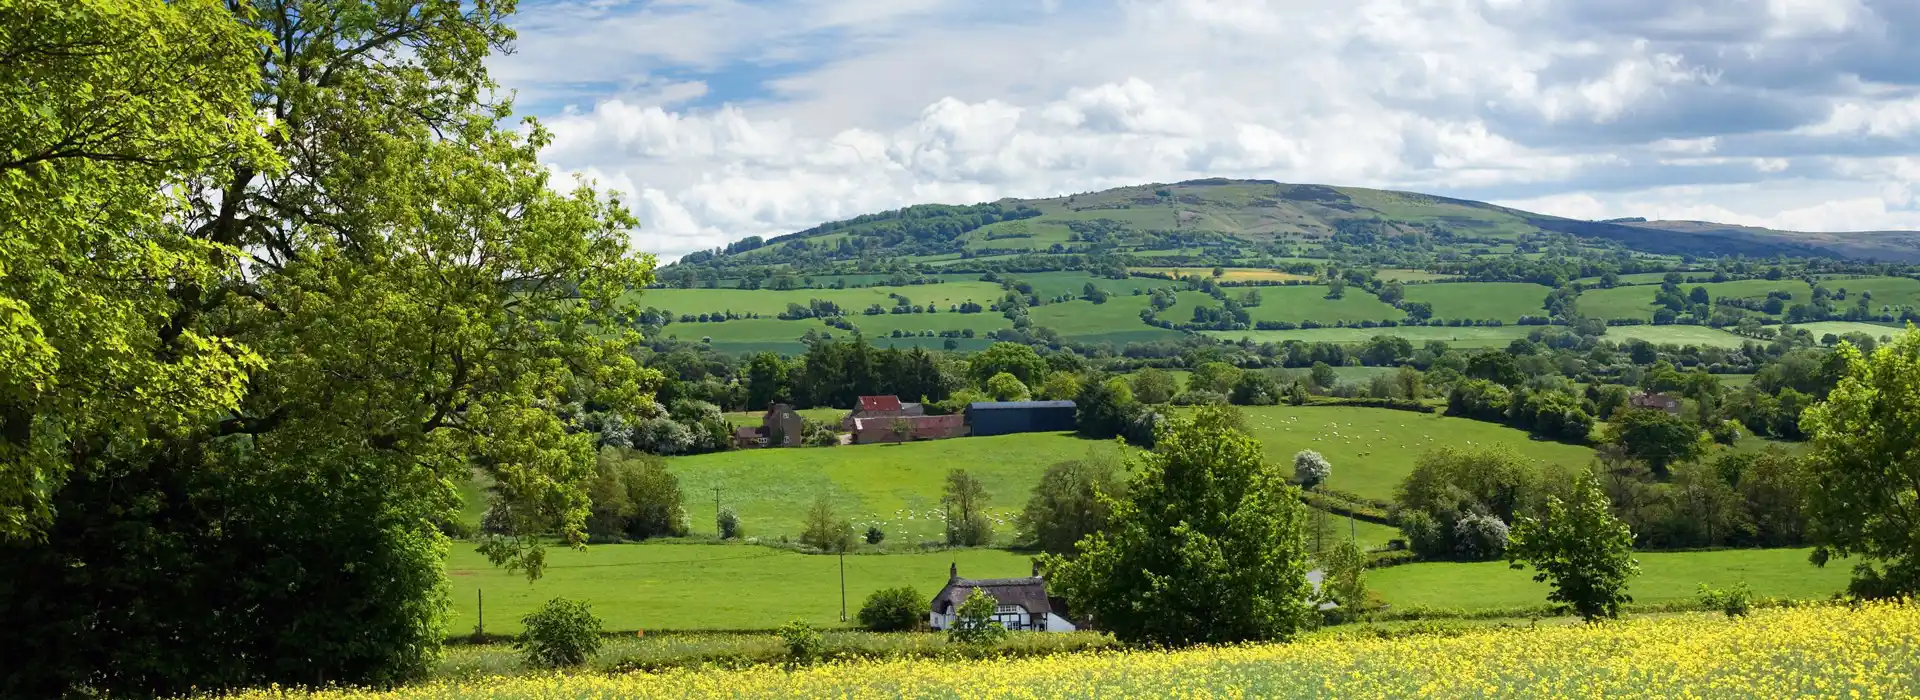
xmin=1801 ymin=324 xmax=1920 ymax=596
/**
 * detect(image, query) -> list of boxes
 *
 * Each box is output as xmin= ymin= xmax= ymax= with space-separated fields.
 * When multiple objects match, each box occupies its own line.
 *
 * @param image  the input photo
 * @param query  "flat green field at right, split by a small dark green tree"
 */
xmin=1367 ymin=548 xmax=1853 ymax=610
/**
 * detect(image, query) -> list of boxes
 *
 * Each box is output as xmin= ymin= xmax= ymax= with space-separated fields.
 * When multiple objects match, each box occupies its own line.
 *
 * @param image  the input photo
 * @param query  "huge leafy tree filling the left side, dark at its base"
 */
xmin=0 ymin=0 xmax=655 ymax=696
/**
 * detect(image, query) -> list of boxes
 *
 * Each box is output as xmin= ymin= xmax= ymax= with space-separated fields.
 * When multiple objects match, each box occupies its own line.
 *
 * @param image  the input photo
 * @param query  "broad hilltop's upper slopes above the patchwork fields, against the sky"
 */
xmin=666 ymin=178 xmax=1920 ymax=280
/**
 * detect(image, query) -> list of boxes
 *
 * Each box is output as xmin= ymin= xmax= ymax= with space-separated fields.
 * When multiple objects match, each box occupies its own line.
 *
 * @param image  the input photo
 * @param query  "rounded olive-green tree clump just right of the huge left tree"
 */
xmin=588 ymin=447 xmax=687 ymax=541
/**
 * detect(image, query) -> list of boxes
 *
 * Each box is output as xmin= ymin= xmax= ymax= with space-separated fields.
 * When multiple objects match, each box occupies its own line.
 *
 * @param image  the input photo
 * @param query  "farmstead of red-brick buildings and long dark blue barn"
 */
xmin=733 ymin=397 xmax=1075 ymax=447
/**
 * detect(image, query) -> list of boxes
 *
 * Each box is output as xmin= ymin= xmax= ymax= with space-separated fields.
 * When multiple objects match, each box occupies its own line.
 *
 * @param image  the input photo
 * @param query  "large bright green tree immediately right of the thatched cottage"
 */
xmin=1043 ymin=408 xmax=1311 ymax=644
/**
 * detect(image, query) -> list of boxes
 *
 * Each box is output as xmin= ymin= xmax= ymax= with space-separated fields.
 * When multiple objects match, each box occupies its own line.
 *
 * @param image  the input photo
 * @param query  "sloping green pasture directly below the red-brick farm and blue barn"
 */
xmin=666 ymin=433 xmax=1112 ymax=547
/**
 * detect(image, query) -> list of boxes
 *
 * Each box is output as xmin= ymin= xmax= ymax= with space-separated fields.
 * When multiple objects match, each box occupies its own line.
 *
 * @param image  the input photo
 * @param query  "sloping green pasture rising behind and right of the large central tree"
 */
xmin=1242 ymin=407 xmax=1594 ymax=501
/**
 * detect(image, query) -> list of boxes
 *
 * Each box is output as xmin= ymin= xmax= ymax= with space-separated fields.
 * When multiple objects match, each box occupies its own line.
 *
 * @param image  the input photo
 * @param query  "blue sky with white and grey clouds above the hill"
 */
xmin=488 ymin=0 xmax=1920 ymax=261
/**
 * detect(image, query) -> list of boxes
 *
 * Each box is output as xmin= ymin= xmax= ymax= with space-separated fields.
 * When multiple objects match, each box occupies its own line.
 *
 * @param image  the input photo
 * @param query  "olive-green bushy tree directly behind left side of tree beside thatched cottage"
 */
xmin=1016 ymin=449 xmax=1121 ymax=554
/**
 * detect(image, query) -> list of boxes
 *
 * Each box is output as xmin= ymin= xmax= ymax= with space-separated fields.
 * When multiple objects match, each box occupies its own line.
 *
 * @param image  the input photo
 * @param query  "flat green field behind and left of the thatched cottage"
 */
xmin=447 ymin=540 xmax=1033 ymax=635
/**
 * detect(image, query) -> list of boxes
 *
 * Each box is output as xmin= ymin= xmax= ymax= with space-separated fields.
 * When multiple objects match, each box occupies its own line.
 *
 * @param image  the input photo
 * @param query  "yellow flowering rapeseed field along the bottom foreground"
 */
xmin=228 ymin=604 xmax=1920 ymax=700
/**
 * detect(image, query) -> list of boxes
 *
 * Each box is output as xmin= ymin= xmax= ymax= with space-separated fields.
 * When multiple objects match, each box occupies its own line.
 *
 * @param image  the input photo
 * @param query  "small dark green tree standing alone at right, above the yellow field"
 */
xmin=1507 ymin=474 xmax=1640 ymax=619
